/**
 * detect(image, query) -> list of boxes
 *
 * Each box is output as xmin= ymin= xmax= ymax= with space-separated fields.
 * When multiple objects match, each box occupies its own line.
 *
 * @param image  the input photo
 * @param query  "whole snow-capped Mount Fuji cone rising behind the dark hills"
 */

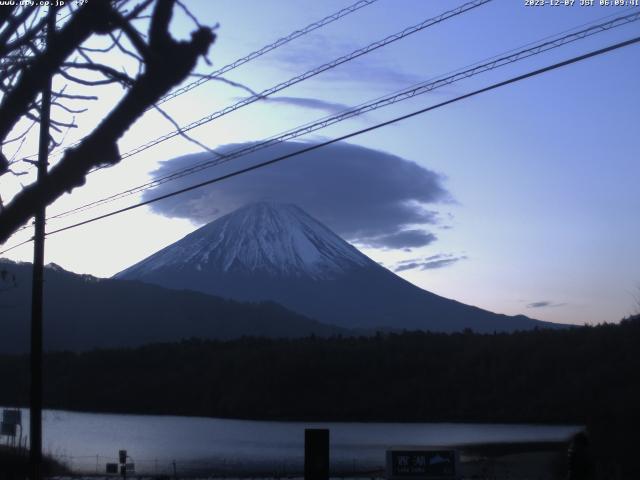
xmin=115 ymin=202 xmax=556 ymax=332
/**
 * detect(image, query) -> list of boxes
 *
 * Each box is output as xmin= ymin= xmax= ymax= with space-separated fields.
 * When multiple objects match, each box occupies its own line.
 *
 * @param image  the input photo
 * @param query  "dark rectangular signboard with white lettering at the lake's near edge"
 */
xmin=387 ymin=449 xmax=459 ymax=480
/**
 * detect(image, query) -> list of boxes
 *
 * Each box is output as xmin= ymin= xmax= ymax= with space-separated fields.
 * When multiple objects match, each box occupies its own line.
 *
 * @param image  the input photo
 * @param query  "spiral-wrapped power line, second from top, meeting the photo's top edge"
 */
xmin=120 ymin=0 xmax=492 ymax=159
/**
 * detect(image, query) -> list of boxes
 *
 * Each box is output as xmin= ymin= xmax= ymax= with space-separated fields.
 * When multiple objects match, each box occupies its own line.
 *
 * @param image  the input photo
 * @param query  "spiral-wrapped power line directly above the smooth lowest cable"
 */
xmin=49 ymin=12 xmax=640 ymax=220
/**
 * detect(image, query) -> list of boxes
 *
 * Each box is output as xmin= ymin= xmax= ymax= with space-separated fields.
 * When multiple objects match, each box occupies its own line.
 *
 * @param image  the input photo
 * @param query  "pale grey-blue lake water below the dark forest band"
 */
xmin=2 ymin=410 xmax=581 ymax=473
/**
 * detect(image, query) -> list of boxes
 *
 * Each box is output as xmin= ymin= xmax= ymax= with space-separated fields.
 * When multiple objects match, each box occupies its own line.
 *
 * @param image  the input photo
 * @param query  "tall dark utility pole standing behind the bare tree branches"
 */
xmin=29 ymin=5 xmax=56 ymax=480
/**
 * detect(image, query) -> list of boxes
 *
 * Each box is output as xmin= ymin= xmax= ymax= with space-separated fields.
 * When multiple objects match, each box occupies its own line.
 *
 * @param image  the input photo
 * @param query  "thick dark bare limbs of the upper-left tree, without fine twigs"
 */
xmin=0 ymin=0 xmax=215 ymax=243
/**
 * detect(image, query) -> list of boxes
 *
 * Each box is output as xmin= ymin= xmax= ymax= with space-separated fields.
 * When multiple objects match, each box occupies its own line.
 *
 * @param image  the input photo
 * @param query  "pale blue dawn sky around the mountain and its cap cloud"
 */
xmin=0 ymin=0 xmax=640 ymax=324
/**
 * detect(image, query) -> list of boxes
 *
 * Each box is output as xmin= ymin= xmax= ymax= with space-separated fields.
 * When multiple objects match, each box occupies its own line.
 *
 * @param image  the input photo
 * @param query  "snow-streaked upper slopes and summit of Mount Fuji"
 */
xmin=116 ymin=202 xmax=376 ymax=279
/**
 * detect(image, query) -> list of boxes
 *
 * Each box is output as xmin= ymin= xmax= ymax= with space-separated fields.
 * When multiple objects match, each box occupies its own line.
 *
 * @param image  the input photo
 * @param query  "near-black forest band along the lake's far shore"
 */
xmin=0 ymin=316 xmax=640 ymax=478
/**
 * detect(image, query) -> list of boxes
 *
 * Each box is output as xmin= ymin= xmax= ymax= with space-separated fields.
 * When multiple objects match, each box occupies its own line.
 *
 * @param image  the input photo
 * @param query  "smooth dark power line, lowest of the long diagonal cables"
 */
xmin=40 ymin=37 xmax=640 ymax=240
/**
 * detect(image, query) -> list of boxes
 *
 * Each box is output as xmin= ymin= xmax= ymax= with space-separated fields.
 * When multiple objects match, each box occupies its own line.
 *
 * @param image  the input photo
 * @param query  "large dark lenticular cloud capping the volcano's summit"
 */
xmin=143 ymin=142 xmax=452 ymax=248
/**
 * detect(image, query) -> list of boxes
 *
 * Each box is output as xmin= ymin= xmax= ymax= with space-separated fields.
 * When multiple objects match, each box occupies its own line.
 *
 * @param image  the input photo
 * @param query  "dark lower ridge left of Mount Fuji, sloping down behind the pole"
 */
xmin=0 ymin=259 xmax=349 ymax=354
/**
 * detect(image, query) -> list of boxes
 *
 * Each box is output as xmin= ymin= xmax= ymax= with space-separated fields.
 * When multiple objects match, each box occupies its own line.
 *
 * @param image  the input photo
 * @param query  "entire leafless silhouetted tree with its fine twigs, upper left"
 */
xmin=0 ymin=0 xmax=215 ymax=244
